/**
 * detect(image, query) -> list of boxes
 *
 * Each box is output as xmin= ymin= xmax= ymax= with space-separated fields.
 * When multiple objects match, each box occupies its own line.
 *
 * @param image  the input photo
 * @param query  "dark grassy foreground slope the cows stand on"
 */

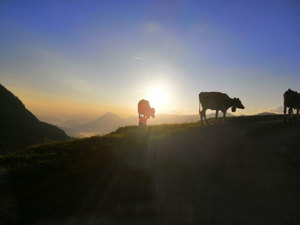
xmin=0 ymin=116 xmax=300 ymax=225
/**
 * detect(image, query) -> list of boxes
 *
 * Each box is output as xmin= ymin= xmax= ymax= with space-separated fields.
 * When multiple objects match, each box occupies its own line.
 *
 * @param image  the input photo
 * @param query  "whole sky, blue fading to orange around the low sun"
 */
xmin=0 ymin=0 xmax=300 ymax=117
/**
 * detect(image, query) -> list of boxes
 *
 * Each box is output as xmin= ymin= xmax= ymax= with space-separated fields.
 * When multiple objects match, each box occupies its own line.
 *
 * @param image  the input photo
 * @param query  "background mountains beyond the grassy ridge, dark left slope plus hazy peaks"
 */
xmin=0 ymin=84 xmax=282 ymax=148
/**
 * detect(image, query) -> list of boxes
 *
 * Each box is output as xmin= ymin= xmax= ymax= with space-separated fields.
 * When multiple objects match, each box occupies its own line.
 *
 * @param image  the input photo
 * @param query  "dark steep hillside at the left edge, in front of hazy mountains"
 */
xmin=0 ymin=84 xmax=69 ymax=153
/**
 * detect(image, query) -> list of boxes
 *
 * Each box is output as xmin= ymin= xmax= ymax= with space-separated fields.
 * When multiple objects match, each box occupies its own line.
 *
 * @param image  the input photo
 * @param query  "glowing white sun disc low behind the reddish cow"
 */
xmin=146 ymin=84 xmax=170 ymax=111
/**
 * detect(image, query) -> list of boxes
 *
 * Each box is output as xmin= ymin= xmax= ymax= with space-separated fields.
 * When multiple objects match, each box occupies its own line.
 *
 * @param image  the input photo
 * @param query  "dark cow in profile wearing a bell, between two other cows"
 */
xmin=199 ymin=92 xmax=245 ymax=124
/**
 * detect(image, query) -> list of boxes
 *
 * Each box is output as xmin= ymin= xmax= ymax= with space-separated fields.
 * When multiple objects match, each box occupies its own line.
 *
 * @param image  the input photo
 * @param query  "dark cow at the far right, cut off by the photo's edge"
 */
xmin=283 ymin=89 xmax=300 ymax=122
